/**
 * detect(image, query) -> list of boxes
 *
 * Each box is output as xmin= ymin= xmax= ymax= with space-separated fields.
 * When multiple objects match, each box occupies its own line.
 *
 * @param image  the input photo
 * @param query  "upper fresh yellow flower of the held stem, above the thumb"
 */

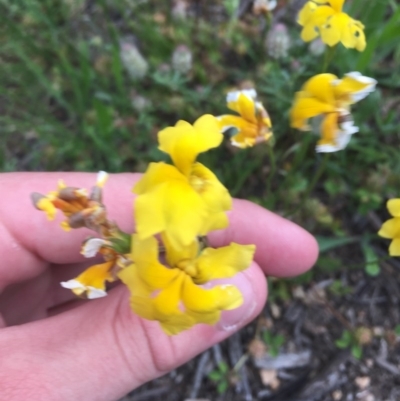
xmin=133 ymin=115 xmax=232 ymax=248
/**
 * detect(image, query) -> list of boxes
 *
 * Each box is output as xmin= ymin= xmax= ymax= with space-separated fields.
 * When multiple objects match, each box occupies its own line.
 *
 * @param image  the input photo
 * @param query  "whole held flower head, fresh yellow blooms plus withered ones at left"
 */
xmin=32 ymin=115 xmax=255 ymax=335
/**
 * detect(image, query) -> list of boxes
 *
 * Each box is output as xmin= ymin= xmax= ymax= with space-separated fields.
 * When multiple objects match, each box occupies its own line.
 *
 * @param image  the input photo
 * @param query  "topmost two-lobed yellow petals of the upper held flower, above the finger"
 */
xmin=158 ymin=114 xmax=223 ymax=174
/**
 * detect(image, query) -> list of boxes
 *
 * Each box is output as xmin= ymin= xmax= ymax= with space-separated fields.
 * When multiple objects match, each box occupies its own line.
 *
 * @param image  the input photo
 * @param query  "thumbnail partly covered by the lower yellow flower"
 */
xmin=216 ymin=271 xmax=257 ymax=332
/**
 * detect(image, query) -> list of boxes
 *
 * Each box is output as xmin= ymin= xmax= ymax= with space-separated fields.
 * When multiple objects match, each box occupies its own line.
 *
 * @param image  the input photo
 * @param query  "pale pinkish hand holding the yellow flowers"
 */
xmin=0 ymin=173 xmax=318 ymax=401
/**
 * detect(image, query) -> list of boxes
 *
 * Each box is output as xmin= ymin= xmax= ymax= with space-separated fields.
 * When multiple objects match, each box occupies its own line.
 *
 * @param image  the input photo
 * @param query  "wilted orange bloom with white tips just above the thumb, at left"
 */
xmin=61 ymin=260 xmax=115 ymax=299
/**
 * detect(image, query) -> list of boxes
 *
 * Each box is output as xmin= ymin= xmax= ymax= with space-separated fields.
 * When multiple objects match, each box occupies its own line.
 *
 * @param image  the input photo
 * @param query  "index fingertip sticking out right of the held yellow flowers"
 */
xmin=209 ymin=199 xmax=318 ymax=277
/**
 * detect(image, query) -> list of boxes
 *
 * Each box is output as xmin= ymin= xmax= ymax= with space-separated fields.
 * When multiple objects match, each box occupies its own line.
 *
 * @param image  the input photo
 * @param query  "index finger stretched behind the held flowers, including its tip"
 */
xmin=0 ymin=173 xmax=318 ymax=284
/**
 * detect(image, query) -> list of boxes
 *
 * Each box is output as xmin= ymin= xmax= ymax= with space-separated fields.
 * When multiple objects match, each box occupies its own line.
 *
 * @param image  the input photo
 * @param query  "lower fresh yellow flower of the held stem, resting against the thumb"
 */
xmin=118 ymin=235 xmax=255 ymax=335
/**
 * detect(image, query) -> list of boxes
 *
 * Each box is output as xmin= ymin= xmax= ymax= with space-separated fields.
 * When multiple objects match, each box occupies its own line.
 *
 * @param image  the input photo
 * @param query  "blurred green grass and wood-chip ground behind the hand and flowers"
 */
xmin=0 ymin=0 xmax=400 ymax=401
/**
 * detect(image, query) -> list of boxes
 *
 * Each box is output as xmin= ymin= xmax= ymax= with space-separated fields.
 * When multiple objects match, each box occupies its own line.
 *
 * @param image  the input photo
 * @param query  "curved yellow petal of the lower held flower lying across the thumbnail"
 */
xmin=182 ymin=276 xmax=243 ymax=313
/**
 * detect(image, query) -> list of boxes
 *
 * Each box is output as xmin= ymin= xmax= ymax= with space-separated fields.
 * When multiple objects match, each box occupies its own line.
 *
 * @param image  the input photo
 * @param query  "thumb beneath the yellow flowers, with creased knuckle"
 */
xmin=0 ymin=264 xmax=266 ymax=401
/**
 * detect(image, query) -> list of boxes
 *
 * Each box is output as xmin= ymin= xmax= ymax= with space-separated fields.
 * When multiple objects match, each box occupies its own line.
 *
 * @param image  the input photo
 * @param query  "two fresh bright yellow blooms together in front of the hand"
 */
xmin=126 ymin=115 xmax=255 ymax=334
